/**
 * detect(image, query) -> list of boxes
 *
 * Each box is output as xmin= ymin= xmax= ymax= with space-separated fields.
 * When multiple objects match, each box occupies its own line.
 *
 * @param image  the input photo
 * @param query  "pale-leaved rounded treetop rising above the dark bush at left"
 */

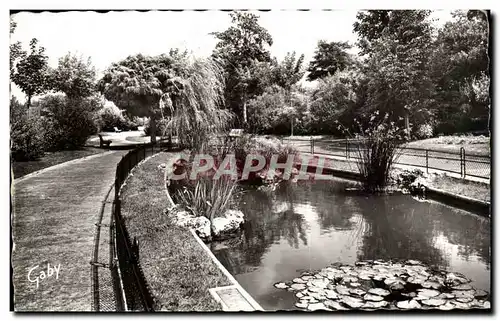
xmin=49 ymin=53 xmax=96 ymax=99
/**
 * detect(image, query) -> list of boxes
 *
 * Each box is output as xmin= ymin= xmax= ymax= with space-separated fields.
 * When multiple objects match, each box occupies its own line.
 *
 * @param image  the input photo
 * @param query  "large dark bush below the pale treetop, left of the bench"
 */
xmin=40 ymin=94 xmax=103 ymax=151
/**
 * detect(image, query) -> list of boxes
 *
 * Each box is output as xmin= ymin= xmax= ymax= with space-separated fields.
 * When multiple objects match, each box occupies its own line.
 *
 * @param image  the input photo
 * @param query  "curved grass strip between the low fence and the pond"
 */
xmin=122 ymin=153 xmax=231 ymax=311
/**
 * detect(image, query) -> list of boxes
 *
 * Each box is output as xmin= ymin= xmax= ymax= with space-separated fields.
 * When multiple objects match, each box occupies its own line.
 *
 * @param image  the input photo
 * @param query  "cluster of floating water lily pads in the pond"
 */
xmin=274 ymin=260 xmax=491 ymax=311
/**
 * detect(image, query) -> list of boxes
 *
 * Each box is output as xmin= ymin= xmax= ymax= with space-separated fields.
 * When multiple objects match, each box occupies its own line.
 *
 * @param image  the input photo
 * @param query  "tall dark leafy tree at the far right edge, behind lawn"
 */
xmin=431 ymin=10 xmax=490 ymax=132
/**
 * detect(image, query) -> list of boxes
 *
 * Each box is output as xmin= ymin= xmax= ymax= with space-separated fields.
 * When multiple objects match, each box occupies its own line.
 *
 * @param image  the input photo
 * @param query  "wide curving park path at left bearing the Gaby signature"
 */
xmin=11 ymin=151 xmax=127 ymax=311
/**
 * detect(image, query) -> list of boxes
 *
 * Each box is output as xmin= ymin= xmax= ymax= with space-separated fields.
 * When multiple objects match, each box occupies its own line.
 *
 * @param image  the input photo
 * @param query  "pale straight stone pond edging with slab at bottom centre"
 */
xmin=189 ymin=229 xmax=264 ymax=311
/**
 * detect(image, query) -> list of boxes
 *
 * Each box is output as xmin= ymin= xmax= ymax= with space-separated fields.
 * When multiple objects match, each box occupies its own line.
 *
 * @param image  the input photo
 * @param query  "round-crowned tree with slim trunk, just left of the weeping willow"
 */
xmin=98 ymin=54 xmax=178 ymax=142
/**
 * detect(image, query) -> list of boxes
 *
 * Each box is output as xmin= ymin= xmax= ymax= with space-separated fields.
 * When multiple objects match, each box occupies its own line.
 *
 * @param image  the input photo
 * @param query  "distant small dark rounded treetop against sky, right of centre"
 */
xmin=307 ymin=40 xmax=351 ymax=81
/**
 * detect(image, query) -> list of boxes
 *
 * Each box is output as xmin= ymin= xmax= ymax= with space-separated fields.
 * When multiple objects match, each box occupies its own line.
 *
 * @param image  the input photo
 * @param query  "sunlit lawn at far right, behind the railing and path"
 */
xmin=406 ymin=135 xmax=490 ymax=155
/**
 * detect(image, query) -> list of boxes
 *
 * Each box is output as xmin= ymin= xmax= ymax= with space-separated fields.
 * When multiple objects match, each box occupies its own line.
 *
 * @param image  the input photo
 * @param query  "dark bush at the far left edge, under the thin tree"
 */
xmin=10 ymin=98 xmax=45 ymax=161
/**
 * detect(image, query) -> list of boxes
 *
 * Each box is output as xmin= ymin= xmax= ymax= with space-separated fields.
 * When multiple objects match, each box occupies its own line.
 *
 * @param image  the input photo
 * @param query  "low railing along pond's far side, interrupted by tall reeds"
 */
xmin=283 ymin=138 xmax=491 ymax=179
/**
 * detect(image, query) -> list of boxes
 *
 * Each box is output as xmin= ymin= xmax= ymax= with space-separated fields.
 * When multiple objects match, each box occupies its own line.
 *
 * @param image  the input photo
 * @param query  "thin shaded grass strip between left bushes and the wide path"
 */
xmin=11 ymin=147 xmax=107 ymax=179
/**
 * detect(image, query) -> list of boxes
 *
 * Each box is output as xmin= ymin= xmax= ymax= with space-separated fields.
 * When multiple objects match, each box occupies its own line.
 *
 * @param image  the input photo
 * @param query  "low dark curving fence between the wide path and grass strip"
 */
xmin=93 ymin=141 xmax=172 ymax=311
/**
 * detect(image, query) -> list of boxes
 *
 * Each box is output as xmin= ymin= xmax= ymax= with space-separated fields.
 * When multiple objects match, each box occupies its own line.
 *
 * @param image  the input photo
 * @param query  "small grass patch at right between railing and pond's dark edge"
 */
xmin=429 ymin=175 xmax=491 ymax=202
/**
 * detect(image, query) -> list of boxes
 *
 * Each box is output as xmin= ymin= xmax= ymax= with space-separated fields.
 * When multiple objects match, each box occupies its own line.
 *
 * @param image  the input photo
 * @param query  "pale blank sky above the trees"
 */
xmin=11 ymin=10 xmax=451 ymax=98
